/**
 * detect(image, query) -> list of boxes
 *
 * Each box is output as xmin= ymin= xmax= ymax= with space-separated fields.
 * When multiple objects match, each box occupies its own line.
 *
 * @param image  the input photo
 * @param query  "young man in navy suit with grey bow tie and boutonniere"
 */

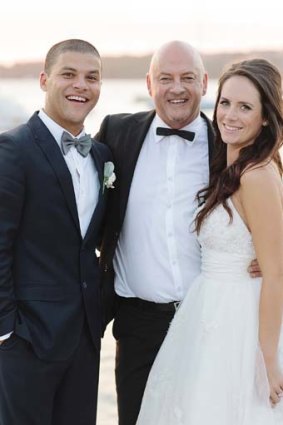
xmin=0 ymin=39 xmax=111 ymax=425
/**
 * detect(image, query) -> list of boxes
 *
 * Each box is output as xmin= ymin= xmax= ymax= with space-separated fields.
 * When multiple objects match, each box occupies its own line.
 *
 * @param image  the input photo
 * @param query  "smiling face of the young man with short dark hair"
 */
xmin=40 ymin=51 xmax=101 ymax=136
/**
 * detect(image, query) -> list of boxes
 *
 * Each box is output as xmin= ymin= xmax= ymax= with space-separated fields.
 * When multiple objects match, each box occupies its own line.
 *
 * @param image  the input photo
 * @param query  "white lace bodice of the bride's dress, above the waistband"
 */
xmin=198 ymin=199 xmax=255 ymax=257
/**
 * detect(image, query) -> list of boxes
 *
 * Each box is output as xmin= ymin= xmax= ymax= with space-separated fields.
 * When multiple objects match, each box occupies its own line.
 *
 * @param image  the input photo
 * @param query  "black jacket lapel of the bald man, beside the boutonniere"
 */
xmin=120 ymin=111 xmax=155 ymax=224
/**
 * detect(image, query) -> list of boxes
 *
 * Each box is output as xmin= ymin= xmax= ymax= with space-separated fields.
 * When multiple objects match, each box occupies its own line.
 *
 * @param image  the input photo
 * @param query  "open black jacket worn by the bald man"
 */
xmin=96 ymin=111 xmax=214 ymax=322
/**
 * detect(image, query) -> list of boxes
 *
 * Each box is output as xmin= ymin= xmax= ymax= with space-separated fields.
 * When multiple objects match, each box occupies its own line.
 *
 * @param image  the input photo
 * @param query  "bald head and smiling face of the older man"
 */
xmin=147 ymin=42 xmax=207 ymax=129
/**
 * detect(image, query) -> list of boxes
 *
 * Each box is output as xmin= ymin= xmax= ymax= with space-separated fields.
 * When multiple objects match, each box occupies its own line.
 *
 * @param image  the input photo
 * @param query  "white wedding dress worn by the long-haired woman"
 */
xmin=137 ymin=199 xmax=283 ymax=425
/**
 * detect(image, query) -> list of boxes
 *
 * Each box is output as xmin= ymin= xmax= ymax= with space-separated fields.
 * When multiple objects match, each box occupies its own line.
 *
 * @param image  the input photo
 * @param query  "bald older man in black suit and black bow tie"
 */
xmin=97 ymin=41 xmax=214 ymax=425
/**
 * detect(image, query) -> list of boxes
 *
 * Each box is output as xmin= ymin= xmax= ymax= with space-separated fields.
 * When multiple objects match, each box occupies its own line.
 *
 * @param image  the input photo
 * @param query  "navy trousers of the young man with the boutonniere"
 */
xmin=0 ymin=326 xmax=99 ymax=425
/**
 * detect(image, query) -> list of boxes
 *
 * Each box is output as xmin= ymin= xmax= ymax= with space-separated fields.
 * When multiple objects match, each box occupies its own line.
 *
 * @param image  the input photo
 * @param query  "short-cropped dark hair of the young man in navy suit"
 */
xmin=44 ymin=39 xmax=101 ymax=74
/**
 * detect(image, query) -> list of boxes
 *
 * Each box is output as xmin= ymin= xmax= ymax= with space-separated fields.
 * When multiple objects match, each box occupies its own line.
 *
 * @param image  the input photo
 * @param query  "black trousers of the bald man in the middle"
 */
xmin=113 ymin=302 xmax=174 ymax=425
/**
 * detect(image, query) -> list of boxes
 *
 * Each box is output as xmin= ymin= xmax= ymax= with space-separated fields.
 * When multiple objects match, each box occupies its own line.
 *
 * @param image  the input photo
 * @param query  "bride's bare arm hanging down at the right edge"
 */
xmin=239 ymin=164 xmax=283 ymax=403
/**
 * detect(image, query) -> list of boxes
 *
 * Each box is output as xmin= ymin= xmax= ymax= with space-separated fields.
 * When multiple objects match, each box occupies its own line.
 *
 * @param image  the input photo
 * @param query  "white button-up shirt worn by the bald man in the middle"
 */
xmin=114 ymin=116 xmax=209 ymax=303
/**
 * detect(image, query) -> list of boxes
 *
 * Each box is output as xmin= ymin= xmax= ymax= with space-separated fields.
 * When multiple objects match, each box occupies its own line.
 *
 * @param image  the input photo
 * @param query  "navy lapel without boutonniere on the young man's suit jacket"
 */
xmin=28 ymin=113 xmax=80 ymax=232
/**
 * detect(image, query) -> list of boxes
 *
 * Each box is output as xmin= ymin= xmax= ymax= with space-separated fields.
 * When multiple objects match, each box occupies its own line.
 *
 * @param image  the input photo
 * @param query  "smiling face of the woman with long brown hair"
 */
xmin=216 ymin=75 xmax=267 ymax=152
